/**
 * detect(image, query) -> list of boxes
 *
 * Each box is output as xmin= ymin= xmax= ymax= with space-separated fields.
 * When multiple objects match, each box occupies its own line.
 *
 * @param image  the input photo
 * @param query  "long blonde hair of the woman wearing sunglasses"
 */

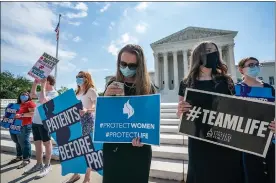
xmin=113 ymin=44 xmax=152 ymax=95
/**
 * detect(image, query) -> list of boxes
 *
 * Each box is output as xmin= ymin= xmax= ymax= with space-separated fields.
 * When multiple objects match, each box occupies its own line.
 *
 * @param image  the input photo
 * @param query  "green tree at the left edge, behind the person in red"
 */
xmin=0 ymin=71 xmax=32 ymax=99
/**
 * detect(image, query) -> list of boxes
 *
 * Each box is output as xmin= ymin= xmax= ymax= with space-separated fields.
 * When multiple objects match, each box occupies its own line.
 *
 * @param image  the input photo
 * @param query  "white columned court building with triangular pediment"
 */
xmin=106 ymin=27 xmax=238 ymax=102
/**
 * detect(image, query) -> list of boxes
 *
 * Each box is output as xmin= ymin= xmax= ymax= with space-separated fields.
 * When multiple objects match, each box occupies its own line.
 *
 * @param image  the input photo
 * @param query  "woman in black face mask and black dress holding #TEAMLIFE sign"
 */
xmin=177 ymin=42 xmax=243 ymax=183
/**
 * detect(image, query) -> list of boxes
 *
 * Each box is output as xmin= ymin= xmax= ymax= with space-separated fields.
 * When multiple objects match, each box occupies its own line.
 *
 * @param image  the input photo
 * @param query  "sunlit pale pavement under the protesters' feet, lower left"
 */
xmin=1 ymin=152 xmax=179 ymax=183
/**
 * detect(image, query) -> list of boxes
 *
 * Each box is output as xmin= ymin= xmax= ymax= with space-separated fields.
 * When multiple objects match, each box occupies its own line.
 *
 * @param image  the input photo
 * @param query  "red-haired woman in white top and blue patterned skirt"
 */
xmin=67 ymin=71 xmax=98 ymax=183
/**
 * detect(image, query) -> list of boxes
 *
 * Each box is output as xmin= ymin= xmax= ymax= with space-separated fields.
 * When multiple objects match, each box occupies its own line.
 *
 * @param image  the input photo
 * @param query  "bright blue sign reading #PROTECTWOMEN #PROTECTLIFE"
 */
xmin=94 ymin=94 xmax=160 ymax=145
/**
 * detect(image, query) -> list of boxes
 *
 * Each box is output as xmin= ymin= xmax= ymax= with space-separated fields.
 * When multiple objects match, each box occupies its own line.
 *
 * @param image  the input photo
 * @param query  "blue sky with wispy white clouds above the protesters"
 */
xmin=1 ymin=2 xmax=275 ymax=91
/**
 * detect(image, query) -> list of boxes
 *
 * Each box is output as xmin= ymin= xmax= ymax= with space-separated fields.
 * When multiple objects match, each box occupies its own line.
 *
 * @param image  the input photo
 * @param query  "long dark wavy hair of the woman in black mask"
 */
xmin=184 ymin=41 xmax=233 ymax=89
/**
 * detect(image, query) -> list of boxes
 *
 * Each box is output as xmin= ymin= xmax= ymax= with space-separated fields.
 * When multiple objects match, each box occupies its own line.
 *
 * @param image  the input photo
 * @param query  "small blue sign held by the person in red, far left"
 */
xmin=1 ymin=103 xmax=22 ymax=134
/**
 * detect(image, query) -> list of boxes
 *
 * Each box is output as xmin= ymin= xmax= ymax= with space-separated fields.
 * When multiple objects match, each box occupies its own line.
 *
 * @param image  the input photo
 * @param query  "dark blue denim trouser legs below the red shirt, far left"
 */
xmin=17 ymin=124 xmax=32 ymax=160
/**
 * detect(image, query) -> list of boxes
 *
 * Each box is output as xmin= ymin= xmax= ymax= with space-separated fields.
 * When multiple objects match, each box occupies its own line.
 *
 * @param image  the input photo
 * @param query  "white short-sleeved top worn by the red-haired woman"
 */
xmin=77 ymin=88 xmax=98 ymax=109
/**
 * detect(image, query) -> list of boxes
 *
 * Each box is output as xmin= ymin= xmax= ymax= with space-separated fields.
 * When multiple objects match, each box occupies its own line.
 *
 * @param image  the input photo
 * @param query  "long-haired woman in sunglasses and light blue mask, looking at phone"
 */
xmin=103 ymin=44 xmax=155 ymax=183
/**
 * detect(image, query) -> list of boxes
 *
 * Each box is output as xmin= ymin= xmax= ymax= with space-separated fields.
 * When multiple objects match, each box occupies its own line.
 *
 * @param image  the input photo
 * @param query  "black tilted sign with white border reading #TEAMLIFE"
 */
xmin=179 ymin=88 xmax=275 ymax=157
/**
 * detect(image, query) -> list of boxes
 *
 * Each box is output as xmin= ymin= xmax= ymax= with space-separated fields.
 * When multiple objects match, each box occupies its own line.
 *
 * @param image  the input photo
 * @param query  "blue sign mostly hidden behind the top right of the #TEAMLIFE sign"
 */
xmin=235 ymin=84 xmax=275 ymax=102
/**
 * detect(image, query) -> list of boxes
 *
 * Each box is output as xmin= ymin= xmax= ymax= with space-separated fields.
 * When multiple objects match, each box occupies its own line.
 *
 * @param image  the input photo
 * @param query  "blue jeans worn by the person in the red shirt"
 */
xmin=10 ymin=124 xmax=32 ymax=160
